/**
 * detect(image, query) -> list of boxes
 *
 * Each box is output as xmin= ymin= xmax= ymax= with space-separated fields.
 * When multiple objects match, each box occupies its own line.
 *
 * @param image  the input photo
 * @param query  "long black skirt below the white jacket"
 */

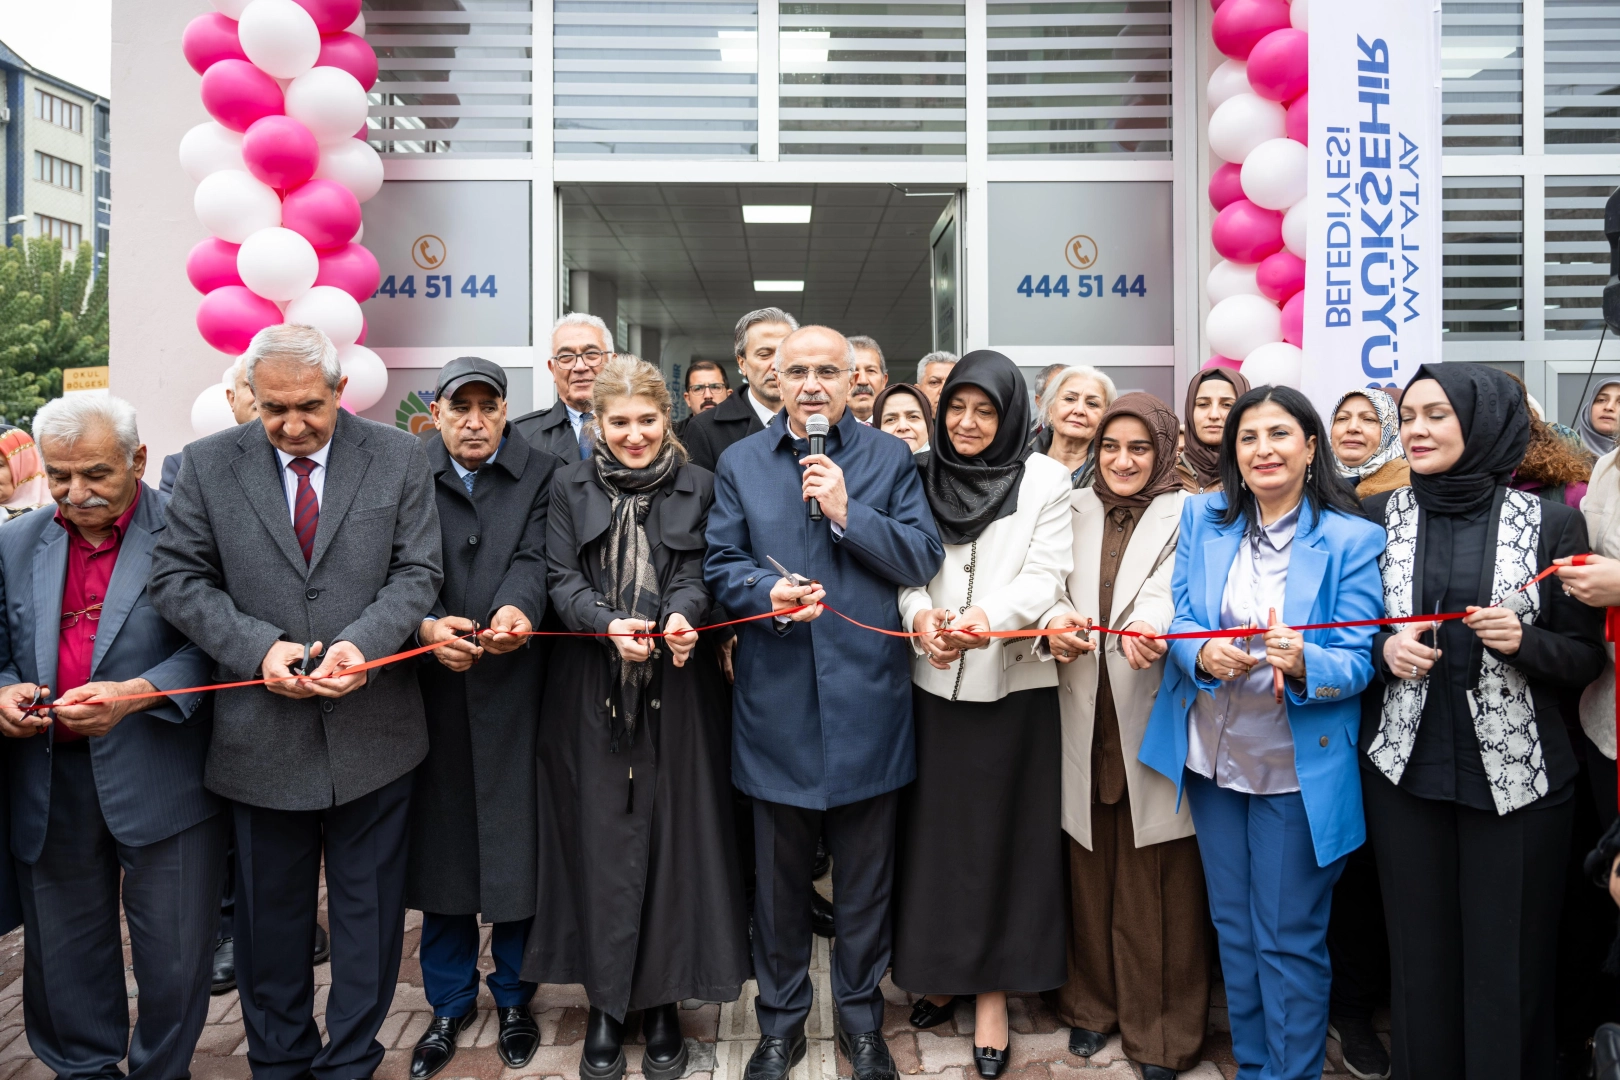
xmin=894 ymin=687 xmax=1068 ymax=994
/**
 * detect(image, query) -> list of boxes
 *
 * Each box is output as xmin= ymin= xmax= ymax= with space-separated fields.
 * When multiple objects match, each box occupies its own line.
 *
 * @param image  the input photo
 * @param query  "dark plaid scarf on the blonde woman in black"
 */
xmin=593 ymin=439 xmax=684 ymax=753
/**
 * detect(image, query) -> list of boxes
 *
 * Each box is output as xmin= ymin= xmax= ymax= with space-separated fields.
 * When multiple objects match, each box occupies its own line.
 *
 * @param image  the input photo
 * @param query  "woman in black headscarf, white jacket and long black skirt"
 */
xmin=894 ymin=351 xmax=1074 ymax=1077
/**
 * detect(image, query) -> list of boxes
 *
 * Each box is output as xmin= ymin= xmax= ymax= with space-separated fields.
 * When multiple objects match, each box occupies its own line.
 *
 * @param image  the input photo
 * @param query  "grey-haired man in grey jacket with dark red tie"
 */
xmin=149 ymin=325 xmax=442 ymax=1080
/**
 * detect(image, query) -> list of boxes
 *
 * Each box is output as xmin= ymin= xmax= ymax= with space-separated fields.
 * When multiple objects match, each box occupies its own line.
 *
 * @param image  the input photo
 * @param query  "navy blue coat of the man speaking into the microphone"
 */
xmin=703 ymin=411 xmax=944 ymax=810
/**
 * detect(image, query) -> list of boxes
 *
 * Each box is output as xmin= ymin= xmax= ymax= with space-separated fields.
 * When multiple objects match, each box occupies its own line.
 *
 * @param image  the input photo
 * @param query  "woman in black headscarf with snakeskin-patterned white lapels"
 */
xmin=1361 ymin=363 xmax=1604 ymax=1080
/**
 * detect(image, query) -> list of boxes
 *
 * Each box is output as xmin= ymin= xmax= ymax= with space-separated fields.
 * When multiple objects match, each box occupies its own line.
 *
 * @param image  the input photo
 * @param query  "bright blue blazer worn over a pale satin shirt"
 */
xmin=1137 ymin=492 xmax=1383 ymax=866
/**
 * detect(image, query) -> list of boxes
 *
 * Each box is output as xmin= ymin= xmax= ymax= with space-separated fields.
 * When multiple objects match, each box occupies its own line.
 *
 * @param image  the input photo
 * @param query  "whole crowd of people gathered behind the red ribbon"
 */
xmin=0 ymin=308 xmax=1620 ymax=1080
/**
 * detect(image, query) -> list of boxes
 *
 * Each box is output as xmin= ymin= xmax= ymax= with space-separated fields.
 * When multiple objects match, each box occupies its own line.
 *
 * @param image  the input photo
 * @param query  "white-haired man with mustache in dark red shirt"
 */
xmin=0 ymin=397 xmax=227 ymax=1080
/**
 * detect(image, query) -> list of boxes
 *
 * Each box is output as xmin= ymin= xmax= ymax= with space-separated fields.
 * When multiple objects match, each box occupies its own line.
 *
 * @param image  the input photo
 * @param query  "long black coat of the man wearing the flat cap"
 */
xmin=405 ymin=427 xmax=559 ymax=923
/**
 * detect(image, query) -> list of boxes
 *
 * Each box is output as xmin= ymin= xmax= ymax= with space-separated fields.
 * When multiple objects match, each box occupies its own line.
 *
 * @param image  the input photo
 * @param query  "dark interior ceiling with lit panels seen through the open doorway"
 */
xmin=561 ymin=183 xmax=949 ymax=369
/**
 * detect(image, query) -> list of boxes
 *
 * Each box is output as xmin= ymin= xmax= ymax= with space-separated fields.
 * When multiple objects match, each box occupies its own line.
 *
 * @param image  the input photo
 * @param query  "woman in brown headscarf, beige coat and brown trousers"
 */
xmin=1045 ymin=393 xmax=1209 ymax=1080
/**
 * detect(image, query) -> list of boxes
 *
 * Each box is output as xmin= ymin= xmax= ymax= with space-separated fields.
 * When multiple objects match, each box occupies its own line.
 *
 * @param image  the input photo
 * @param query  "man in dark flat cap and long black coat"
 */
xmin=405 ymin=356 xmax=561 ymax=1080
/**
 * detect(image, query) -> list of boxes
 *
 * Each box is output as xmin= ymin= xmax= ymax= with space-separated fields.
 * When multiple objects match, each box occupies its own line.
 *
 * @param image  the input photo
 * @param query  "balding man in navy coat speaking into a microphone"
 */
xmin=703 ymin=327 xmax=944 ymax=1080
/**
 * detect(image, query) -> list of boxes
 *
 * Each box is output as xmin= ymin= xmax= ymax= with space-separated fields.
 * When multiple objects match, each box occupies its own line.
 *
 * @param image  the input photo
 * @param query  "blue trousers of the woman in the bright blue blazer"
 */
xmin=1186 ymin=771 xmax=1345 ymax=1080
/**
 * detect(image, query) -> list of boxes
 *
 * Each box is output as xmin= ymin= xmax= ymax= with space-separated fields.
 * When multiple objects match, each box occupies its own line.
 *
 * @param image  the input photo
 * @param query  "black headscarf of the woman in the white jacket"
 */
xmin=923 ymin=348 xmax=1030 ymax=544
